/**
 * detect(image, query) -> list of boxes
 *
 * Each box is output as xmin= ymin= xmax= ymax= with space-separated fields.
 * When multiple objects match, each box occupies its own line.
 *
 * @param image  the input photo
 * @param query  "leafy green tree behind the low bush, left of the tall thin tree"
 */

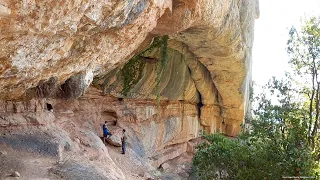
xmin=249 ymin=77 xmax=317 ymax=176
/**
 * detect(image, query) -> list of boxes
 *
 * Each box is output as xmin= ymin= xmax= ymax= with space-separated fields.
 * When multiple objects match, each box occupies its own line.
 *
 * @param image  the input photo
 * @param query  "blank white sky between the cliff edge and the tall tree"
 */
xmin=252 ymin=0 xmax=320 ymax=85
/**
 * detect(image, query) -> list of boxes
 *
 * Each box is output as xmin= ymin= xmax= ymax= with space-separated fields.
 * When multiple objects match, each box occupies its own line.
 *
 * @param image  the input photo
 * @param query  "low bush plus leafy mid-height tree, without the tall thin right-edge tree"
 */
xmin=193 ymin=79 xmax=316 ymax=180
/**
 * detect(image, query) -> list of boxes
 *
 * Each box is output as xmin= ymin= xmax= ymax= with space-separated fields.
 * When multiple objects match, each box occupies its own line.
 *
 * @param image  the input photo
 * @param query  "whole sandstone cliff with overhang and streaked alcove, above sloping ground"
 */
xmin=0 ymin=0 xmax=259 ymax=178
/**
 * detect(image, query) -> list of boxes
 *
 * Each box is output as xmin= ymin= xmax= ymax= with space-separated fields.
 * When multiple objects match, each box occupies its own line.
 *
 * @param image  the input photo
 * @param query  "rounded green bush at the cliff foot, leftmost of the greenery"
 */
xmin=193 ymin=134 xmax=253 ymax=179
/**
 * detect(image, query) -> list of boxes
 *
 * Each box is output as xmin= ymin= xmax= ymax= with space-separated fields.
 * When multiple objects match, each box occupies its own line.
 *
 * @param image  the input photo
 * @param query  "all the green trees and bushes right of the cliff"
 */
xmin=193 ymin=18 xmax=320 ymax=180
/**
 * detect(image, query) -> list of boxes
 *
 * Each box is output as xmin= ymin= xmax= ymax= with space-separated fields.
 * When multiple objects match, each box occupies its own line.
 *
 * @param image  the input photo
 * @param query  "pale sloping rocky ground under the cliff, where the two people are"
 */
xmin=0 ymin=107 xmax=192 ymax=180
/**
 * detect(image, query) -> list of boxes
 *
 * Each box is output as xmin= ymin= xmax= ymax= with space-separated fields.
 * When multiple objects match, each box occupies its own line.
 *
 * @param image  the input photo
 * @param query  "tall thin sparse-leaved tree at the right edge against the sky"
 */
xmin=287 ymin=17 xmax=320 ymax=148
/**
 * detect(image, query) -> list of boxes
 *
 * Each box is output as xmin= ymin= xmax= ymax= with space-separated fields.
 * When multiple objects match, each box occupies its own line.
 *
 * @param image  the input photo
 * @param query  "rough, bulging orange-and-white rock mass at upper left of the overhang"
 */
xmin=0 ymin=0 xmax=170 ymax=99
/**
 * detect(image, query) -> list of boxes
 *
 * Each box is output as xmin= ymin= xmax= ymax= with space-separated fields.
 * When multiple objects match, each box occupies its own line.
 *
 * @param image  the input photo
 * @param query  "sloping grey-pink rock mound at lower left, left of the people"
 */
xmin=0 ymin=96 xmax=125 ymax=180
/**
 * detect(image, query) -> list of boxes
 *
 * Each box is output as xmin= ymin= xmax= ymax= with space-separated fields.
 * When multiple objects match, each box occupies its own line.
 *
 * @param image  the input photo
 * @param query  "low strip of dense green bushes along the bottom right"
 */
xmin=193 ymin=131 xmax=314 ymax=180
